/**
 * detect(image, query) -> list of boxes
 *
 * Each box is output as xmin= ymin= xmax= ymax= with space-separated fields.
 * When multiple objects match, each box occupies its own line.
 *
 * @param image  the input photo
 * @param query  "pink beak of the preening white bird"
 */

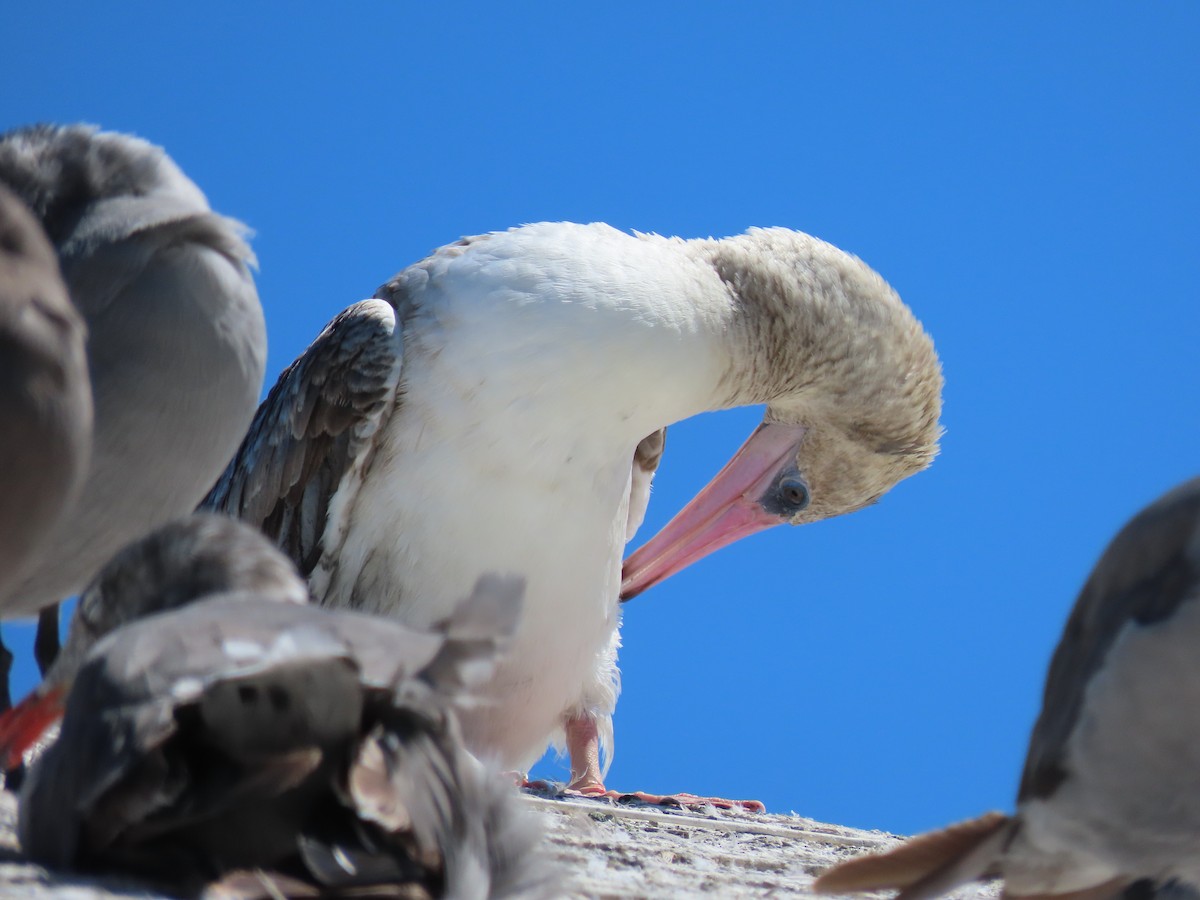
xmin=620 ymin=422 xmax=804 ymax=600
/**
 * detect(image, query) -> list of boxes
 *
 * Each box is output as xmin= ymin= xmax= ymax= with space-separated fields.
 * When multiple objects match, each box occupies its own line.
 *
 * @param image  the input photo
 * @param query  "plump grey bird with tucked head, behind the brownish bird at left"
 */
xmin=0 ymin=125 xmax=266 ymax=676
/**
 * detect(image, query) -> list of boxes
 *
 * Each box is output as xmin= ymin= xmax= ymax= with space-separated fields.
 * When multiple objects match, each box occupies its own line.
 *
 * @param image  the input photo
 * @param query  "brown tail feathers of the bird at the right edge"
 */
xmin=812 ymin=812 xmax=1014 ymax=900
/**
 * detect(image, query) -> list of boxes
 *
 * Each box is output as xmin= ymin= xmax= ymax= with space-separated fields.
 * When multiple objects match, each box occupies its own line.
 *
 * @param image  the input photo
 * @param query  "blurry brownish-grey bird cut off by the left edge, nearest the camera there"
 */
xmin=0 ymin=185 xmax=92 ymax=697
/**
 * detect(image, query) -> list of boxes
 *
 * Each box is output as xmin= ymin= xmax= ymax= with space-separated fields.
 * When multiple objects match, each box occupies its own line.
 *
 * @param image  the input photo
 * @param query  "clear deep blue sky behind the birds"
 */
xmin=0 ymin=2 xmax=1200 ymax=832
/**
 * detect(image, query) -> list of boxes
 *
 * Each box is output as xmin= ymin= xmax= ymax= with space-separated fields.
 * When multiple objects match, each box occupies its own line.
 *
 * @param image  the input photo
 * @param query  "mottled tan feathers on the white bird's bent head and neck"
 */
xmin=695 ymin=228 xmax=943 ymax=520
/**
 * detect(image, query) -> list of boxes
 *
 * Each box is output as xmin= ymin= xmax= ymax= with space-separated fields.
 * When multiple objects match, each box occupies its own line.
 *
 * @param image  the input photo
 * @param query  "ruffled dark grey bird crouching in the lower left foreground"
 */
xmin=19 ymin=517 xmax=551 ymax=898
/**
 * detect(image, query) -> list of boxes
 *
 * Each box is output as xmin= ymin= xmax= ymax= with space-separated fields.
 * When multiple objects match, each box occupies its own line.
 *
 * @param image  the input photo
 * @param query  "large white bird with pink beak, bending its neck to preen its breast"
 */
xmin=205 ymin=223 xmax=942 ymax=793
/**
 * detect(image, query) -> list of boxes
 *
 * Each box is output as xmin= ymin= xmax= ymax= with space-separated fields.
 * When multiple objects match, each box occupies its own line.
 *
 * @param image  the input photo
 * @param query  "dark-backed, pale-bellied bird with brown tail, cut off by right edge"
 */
xmin=815 ymin=479 xmax=1200 ymax=900
